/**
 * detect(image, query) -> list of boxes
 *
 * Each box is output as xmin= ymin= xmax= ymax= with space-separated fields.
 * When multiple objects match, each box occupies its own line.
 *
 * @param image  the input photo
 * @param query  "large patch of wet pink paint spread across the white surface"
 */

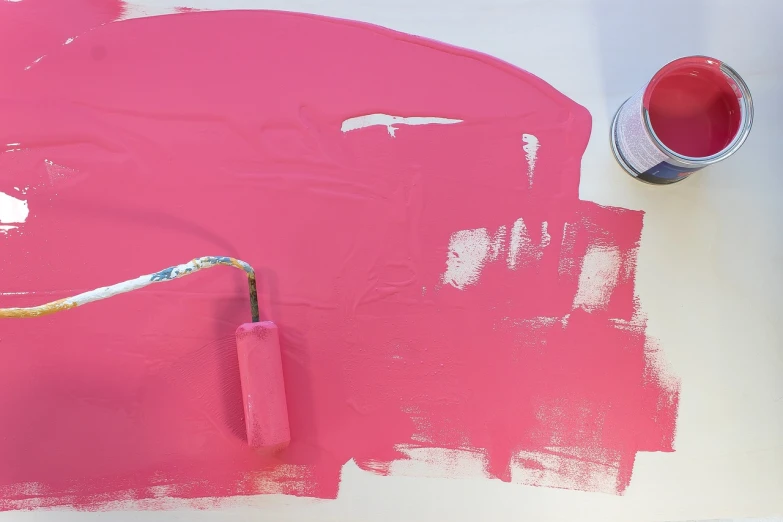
xmin=0 ymin=0 xmax=678 ymax=509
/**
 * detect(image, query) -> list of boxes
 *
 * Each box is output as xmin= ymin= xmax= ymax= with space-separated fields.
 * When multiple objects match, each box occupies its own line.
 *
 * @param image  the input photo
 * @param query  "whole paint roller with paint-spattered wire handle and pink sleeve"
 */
xmin=0 ymin=256 xmax=291 ymax=453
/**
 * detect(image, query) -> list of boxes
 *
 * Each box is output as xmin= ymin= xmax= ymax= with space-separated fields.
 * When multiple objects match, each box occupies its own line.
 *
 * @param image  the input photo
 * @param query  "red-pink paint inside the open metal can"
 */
xmin=645 ymin=58 xmax=741 ymax=158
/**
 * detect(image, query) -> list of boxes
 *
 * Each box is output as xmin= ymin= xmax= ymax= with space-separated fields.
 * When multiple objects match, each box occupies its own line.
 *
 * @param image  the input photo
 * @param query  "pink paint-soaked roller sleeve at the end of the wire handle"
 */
xmin=237 ymin=321 xmax=291 ymax=453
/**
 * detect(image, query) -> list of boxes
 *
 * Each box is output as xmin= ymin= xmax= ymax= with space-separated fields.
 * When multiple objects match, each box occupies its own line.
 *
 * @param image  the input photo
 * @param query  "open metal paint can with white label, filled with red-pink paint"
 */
xmin=611 ymin=56 xmax=753 ymax=185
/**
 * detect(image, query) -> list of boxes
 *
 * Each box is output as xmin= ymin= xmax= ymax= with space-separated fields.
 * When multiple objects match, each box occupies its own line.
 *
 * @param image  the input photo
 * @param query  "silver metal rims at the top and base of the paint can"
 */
xmin=609 ymin=55 xmax=753 ymax=185
